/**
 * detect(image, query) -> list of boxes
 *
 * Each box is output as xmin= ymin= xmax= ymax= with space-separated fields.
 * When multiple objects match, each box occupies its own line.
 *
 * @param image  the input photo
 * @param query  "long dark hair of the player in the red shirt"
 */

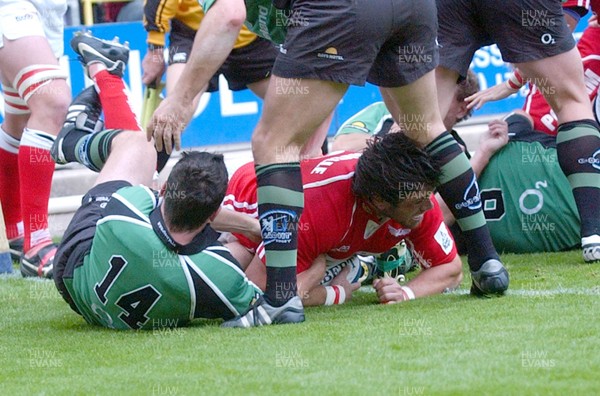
xmin=352 ymin=133 xmax=441 ymax=206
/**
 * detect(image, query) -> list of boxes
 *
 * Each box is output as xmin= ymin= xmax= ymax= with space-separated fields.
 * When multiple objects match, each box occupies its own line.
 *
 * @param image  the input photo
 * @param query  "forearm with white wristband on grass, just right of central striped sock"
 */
xmin=298 ymin=254 xmax=360 ymax=307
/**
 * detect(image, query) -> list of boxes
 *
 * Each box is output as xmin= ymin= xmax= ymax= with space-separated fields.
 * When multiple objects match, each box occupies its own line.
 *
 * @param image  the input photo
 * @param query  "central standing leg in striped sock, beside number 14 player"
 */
xmin=224 ymin=75 xmax=348 ymax=327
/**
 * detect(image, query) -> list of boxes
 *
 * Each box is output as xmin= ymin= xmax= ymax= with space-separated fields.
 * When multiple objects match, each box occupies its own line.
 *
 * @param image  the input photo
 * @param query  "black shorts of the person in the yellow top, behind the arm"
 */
xmin=169 ymin=19 xmax=278 ymax=92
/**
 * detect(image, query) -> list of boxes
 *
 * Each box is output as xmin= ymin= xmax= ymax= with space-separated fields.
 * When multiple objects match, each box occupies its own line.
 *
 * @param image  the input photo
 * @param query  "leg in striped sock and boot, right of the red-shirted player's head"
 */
xmin=381 ymin=71 xmax=509 ymax=295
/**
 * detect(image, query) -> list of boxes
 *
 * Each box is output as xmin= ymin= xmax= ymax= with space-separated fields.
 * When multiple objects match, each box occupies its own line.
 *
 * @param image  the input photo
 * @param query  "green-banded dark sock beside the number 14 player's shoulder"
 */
xmin=255 ymin=162 xmax=304 ymax=306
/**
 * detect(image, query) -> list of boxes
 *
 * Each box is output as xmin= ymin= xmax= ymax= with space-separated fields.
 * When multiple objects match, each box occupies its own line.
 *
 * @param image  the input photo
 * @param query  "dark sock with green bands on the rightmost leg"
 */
xmin=556 ymin=120 xmax=600 ymax=238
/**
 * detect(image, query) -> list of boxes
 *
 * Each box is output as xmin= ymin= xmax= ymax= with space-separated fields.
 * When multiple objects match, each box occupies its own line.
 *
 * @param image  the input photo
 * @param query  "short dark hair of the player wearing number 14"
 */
xmin=163 ymin=151 xmax=228 ymax=231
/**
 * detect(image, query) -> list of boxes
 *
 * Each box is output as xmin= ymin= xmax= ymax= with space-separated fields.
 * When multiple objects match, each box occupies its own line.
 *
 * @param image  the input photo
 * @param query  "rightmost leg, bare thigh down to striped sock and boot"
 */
xmin=517 ymin=48 xmax=600 ymax=262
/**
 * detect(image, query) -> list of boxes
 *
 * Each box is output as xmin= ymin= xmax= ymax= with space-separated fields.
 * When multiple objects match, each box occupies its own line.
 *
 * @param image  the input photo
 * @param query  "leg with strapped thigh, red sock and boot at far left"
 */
xmin=0 ymin=32 xmax=70 ymax=277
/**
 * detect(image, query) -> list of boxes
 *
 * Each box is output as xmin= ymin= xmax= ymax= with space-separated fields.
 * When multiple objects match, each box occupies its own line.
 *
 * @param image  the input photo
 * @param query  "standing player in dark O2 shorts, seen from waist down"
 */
xmin=436 ymin=0 xmax=600 ymax=263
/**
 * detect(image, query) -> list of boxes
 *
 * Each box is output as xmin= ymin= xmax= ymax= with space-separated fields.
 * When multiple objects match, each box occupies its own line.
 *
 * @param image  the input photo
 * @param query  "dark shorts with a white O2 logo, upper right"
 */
xmin=436 ymin=0 xmax=575 ymax=77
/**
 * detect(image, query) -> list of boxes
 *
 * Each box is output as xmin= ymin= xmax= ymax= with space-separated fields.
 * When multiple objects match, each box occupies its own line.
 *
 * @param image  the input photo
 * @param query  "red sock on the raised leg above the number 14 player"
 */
xmin=94 ymin=70 xmax=142 ymax=131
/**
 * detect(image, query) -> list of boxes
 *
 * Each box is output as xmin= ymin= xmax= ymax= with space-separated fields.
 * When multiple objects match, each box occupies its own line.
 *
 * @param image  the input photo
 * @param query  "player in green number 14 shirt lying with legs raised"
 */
xmin=52 ymin=35 xmax=297 ymax=329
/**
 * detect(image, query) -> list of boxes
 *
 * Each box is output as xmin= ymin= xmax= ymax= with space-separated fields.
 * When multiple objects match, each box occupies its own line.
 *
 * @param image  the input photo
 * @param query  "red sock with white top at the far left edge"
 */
xmin=0 ymin=127 xmax=23 ymax=239
